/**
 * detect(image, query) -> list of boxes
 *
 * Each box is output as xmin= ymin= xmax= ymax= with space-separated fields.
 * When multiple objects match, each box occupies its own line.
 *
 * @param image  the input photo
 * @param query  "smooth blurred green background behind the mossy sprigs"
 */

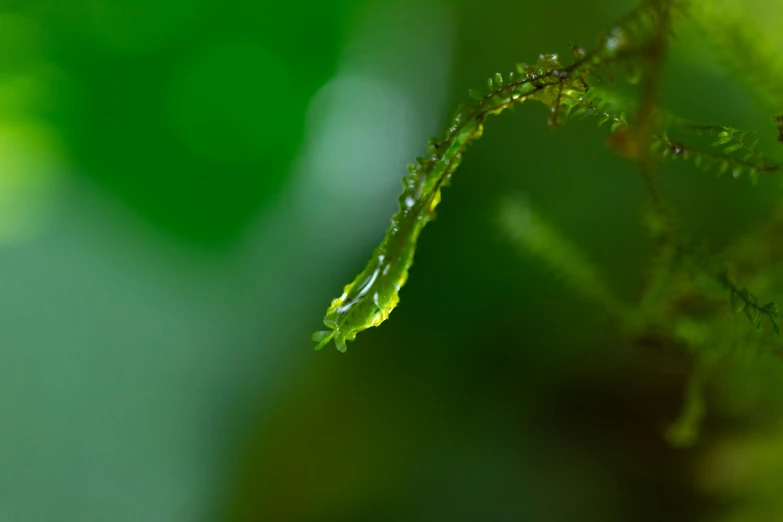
xmin=0 ymin=0 xmax=783 ymax=522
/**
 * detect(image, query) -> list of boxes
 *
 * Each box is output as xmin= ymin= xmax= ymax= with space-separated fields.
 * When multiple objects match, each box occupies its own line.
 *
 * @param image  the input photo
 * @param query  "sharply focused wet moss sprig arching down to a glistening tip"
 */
xmin=314 ymin=4 xmax=672 ymax=351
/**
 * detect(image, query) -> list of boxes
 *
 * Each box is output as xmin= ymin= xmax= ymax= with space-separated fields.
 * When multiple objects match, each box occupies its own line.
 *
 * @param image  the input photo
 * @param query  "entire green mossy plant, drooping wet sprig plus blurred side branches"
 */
xmin=313 ymin=0 xmax=783 ymax=445
